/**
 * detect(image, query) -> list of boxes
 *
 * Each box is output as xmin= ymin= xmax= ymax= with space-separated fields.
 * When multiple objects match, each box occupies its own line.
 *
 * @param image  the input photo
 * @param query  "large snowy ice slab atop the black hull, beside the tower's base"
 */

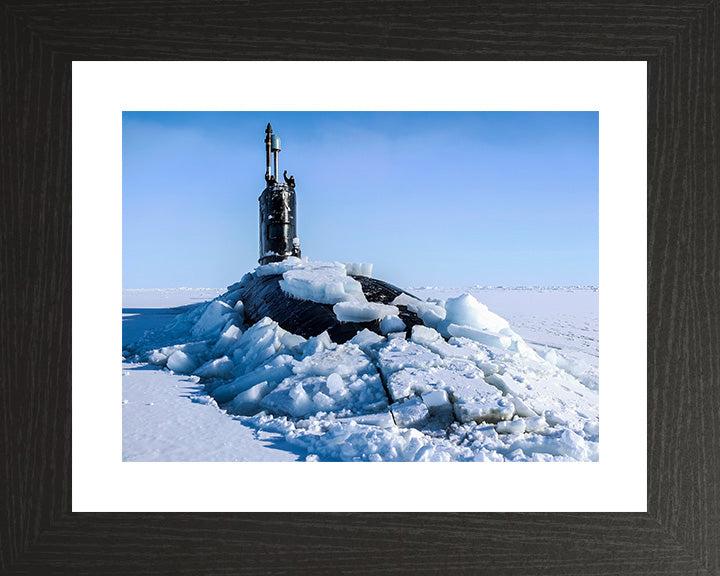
xmin=280 ymin=262 xmax=367 ymax=304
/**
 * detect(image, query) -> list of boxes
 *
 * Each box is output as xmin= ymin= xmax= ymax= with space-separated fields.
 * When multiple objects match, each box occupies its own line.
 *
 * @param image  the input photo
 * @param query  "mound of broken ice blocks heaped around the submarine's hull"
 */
xmin=124 ymin=258 xmax=599 ymax=461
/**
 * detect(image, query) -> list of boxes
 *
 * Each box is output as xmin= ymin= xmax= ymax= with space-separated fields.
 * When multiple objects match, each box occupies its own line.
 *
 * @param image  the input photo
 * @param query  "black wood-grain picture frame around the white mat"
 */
xmin=0 ymin=0 xmax=720 ymax=576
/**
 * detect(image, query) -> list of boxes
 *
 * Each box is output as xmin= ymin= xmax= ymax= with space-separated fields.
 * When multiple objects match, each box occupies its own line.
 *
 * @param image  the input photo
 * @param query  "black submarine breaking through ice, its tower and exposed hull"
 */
xmin=239 ymin=123 xmax=423 ymax=344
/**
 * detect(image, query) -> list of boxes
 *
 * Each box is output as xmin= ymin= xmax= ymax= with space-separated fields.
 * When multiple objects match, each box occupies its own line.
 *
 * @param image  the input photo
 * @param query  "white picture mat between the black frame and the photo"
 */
xmin=72 ymin=62 xmax=647 ymax=512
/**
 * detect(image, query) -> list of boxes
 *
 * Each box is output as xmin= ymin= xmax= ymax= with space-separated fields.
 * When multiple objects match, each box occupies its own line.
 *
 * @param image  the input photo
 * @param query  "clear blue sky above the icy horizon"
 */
xmin=122 ymin=112 xmax=599 ymax=288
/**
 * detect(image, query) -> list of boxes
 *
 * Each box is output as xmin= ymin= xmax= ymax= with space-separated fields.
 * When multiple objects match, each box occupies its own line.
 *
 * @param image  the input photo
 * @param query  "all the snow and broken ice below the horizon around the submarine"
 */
xmin=122 ymin=262 xmax=599 ymax=461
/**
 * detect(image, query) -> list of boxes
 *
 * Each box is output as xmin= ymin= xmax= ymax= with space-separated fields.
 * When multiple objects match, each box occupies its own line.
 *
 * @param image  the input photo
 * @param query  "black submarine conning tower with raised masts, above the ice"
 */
xmin=258 ymin=123 xmax=300 ymax=264
